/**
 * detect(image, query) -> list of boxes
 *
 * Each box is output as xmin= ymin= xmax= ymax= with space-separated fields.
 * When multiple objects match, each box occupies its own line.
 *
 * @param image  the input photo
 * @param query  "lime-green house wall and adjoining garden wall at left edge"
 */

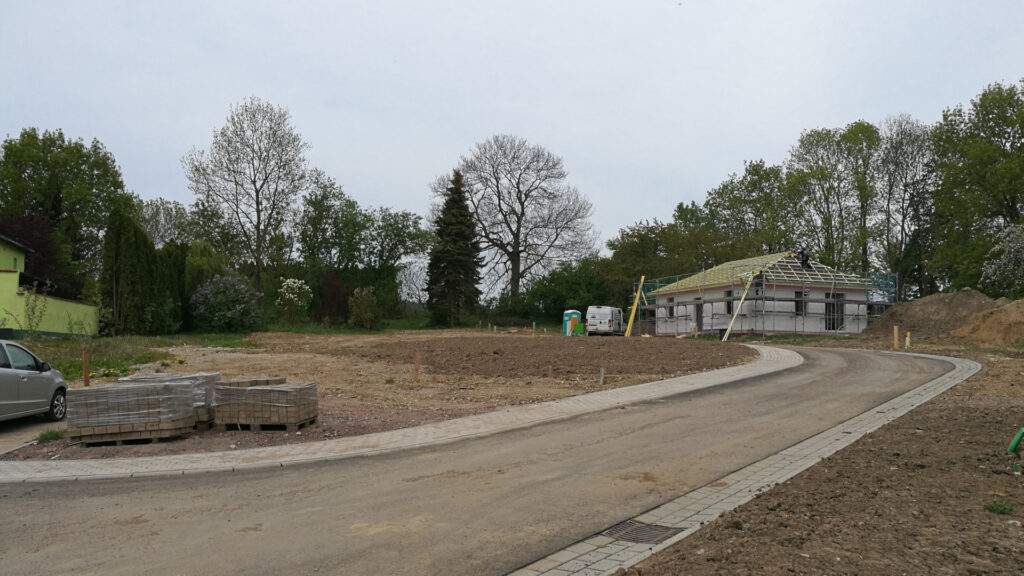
xmin=0 ymin=272 xmax=99 ymax=335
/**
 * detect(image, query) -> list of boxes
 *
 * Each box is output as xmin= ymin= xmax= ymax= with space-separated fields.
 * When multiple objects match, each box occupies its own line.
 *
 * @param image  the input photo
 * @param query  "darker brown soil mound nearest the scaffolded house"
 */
xmin=862 ymin=288 xmax=995 ymax=338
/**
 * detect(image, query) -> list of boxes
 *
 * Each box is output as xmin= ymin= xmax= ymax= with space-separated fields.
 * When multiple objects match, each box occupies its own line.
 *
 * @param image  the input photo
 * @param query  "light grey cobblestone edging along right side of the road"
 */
xmin=510 ymin=353 xmax=981 ymax=576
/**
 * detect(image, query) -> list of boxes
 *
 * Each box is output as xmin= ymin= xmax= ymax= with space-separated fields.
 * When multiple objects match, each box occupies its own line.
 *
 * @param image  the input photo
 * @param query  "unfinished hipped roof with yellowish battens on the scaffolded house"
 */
xmin=651 ymin=252 xmax=871 ymax=295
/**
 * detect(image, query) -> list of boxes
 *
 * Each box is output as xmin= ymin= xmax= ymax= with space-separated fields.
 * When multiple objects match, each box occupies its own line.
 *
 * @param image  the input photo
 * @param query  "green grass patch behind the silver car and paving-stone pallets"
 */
xmin=25 ymin=334 xmax=259 ymax=380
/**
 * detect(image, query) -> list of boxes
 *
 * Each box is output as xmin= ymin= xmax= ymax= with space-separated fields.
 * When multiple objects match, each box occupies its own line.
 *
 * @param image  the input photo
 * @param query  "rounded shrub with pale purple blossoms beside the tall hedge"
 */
xmin=191 ymin=275 xmax=261 ymax=332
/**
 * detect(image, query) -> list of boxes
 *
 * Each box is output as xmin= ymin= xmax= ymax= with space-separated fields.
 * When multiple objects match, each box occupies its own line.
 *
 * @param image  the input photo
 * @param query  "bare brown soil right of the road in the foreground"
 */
xmin=621 ymin=346 xmax=1024 ymax=576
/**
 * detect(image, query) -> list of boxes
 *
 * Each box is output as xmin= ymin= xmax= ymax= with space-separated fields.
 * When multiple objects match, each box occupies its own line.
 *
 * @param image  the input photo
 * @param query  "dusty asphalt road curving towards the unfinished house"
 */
xmin=0 ymin=348 xmax=950 ymax=576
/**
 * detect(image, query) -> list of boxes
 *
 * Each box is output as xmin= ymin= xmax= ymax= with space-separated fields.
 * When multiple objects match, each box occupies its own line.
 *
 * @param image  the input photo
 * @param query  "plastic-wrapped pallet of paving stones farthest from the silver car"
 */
xmin=214 ymin=382 xmax=318 ymax=429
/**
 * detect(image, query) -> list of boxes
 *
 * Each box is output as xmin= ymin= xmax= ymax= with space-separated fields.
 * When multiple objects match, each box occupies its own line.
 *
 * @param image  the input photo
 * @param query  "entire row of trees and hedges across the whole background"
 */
xmin=0 ymin=81 xmax=1024 ymax=333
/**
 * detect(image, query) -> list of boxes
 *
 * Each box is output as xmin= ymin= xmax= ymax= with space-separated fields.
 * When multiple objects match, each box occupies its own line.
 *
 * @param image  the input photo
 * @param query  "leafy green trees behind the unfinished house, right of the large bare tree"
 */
xmin=522 ymin=80 xmax=1024 ymax=318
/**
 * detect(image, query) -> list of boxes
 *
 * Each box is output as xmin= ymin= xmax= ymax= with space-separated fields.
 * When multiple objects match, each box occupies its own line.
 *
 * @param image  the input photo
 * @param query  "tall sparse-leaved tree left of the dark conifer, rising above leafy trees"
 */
xmin=181 ymin=97 xmax=309 ymax=289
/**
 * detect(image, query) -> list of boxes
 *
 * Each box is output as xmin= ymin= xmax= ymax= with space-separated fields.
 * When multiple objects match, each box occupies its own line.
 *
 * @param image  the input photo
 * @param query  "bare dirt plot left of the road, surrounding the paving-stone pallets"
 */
xmin=0 ymin=330 xmax=757 ymax=459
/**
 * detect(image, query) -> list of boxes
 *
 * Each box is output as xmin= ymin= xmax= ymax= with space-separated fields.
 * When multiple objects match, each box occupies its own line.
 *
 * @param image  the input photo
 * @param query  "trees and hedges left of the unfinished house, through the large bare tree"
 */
xmin=0 ymin=97 xmax=593 ymax=333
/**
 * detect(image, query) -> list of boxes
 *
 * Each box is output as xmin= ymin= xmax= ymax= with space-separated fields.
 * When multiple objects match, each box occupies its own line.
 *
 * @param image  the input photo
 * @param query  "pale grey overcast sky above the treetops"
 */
xmin=0 ymin=0 xmax=1024 ymax=249
